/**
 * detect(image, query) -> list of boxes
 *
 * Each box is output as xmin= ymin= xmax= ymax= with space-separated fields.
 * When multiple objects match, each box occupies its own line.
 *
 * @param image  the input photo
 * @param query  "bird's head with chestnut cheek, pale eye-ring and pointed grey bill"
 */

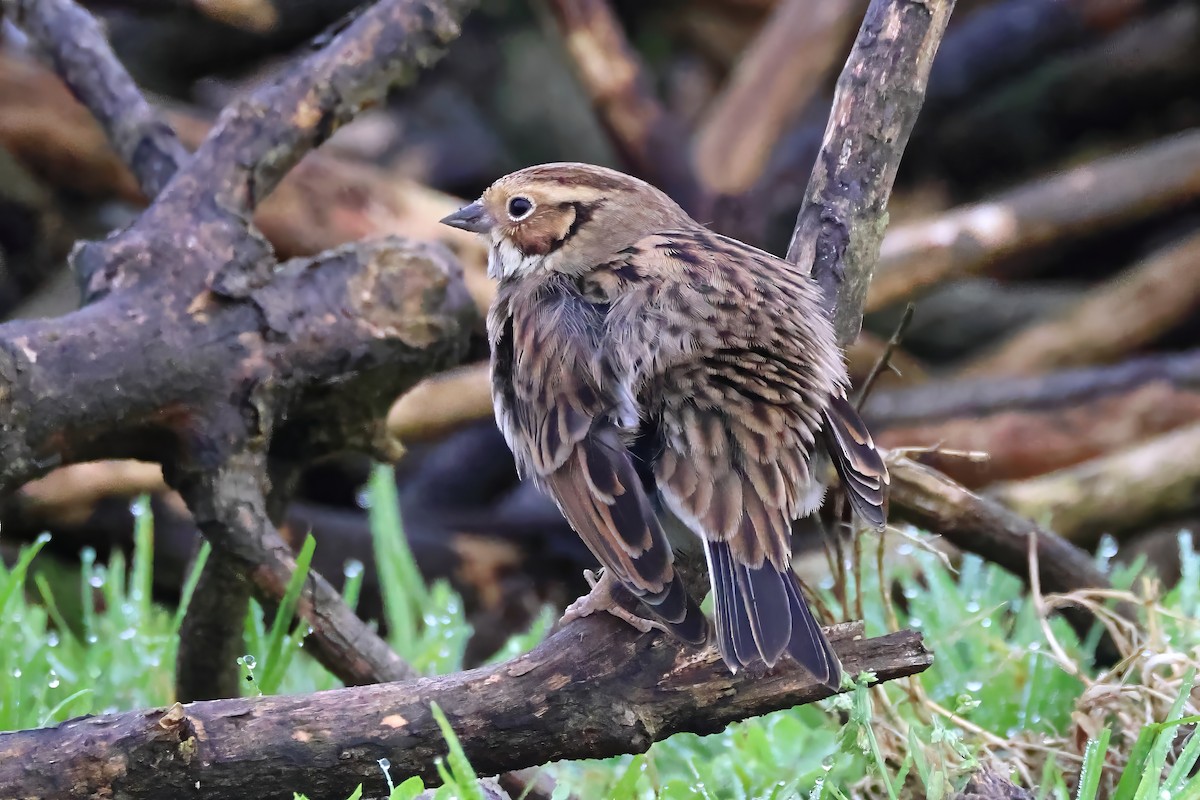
xmin=442 ymin=163 xmax=695 ymax=281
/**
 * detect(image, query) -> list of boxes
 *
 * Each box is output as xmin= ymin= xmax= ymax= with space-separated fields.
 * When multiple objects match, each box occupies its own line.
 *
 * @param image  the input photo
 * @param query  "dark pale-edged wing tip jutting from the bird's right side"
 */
xmin=824 ymin=396 xmax=888 ymax=529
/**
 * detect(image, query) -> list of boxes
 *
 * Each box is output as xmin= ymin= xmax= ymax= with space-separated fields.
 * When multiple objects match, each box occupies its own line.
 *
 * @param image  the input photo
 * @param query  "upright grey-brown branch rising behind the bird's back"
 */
xmin=787 ymin=0 xmax=954 ymax=345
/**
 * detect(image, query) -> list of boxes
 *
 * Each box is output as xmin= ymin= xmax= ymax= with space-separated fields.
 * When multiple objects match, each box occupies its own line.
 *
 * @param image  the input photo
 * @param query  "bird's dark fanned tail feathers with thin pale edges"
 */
xmin=706 ymin=542 xmax=841 ymax=687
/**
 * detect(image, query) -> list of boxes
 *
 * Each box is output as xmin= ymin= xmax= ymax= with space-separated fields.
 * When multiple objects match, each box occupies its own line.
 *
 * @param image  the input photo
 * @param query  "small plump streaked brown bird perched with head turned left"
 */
xmin=442 ymin=163 xmax=888 ymax=686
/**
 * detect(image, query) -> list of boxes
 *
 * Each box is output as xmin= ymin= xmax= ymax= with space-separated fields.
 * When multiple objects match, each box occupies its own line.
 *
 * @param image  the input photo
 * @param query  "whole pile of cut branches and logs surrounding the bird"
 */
xmin=0 ymin=0 xmax=1200 ymax=796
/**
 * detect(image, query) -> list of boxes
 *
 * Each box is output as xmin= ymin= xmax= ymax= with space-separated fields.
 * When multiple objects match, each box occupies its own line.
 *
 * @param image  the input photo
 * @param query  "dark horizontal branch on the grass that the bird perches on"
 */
xmin=0 ymin=614 xmax=932 ymax=800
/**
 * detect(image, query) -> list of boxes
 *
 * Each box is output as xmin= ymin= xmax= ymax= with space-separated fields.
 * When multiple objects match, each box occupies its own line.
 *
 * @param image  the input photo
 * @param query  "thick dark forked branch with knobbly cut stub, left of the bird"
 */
xmin=0 ymin=0 xmax=478 ymax=695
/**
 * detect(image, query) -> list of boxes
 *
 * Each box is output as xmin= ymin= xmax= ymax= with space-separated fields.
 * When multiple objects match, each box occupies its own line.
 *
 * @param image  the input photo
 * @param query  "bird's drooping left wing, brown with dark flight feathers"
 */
xmin=492 ymin=281 xmax=707 ymax=643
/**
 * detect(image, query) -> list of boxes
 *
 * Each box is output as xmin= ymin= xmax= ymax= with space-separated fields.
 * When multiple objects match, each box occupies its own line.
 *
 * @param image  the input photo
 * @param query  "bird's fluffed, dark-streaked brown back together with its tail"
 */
xmin=636 ymin=231 xmax=846 ymax=685
